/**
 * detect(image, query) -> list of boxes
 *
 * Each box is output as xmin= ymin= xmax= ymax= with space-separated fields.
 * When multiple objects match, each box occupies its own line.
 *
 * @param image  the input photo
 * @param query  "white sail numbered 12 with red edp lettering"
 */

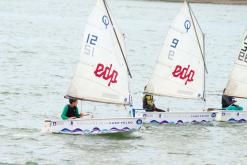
xmin=67 ymin=0 xmax=129 ymax=104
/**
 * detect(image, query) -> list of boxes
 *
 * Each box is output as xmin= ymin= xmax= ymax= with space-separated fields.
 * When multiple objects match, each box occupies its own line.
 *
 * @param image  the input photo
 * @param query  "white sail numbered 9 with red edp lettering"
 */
xmin=145 ymin=1 xmax=206 ymax=99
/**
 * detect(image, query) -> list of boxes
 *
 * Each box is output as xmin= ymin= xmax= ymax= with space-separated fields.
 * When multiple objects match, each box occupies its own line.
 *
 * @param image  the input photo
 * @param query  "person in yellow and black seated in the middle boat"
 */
xmin=142 ymin=94 xmax=165 ymax=112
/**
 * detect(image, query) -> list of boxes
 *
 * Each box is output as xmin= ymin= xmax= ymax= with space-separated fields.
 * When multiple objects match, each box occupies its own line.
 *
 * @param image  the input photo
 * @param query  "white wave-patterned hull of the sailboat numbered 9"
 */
xmin=135 ymin=111 xmax=216 ymax=124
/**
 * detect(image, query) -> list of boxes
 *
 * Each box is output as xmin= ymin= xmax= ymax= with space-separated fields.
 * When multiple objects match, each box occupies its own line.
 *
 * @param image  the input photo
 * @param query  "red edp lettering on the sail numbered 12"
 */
xmin=94 ymin=63 xmax=118 ymax=86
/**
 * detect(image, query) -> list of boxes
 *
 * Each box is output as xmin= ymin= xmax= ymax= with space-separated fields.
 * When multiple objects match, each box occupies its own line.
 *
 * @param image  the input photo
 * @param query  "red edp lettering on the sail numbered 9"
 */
xmin=172 ymin=65 xmax=195 ymax=85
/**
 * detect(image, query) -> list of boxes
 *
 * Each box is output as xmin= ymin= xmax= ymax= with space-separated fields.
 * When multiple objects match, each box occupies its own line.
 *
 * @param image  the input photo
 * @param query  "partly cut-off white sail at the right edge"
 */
xmin=224 ymin=31 xmax=247 ymax=98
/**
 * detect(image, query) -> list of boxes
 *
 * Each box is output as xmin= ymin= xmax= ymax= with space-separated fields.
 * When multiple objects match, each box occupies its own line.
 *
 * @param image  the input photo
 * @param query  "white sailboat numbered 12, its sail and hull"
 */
xmin=45 ymin=0 xmax=143 ymax=134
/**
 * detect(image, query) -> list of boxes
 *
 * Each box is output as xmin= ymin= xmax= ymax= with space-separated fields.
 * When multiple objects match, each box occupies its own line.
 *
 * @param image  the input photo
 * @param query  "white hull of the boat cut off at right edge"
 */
xmin=213 ymin=109 xmax=247 ymax=123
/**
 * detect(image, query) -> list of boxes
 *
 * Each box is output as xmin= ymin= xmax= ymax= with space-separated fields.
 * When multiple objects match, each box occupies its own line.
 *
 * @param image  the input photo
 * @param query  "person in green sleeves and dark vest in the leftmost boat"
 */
xmin=61 ymin=99 xmax=85 ymax=120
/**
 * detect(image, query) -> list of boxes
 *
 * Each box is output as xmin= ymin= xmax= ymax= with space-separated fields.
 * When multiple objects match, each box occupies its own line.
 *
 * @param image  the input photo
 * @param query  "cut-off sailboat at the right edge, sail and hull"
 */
xmin=212 ymin=31 xmax=247 ymax=122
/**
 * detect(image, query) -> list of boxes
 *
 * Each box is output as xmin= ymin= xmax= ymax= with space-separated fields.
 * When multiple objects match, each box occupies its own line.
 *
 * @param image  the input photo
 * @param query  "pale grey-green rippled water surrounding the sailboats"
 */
xmin=0 ymin=0 xmax=247 ymax=164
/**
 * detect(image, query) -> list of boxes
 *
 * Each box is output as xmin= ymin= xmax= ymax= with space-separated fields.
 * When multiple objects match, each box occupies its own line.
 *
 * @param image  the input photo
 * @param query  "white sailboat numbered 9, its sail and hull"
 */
xmin=133 ymin=0 xmax=216 ymax=124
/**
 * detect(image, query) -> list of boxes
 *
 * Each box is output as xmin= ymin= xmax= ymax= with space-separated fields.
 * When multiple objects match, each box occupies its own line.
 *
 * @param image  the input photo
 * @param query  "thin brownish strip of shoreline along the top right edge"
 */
xmin=149 ymin=0 xmax=247 ymax=5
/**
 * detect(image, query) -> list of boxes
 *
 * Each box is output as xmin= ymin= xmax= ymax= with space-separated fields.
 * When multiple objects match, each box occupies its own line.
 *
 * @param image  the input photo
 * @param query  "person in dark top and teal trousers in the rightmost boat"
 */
xmin=221 ymin=89 xmax=243 ymax=111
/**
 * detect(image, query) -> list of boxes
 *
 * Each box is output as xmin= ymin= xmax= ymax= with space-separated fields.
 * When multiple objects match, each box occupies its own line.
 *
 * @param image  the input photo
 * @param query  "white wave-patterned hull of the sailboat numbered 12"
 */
xmin=42 ymin=117 xmax=143 ymax=135
